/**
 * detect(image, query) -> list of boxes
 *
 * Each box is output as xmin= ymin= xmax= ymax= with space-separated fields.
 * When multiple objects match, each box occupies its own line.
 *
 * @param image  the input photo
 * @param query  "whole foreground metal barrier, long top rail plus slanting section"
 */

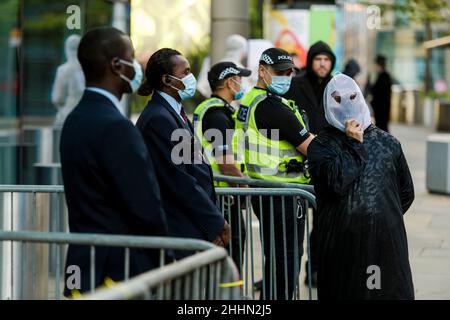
xmin=0 ymin=231 xmax=240 ymax=300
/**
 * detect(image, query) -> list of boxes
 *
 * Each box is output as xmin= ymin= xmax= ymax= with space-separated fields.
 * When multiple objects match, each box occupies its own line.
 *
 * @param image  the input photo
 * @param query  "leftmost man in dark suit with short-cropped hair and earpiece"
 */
xmin=60 ymin=28 xmax=167 ymax=295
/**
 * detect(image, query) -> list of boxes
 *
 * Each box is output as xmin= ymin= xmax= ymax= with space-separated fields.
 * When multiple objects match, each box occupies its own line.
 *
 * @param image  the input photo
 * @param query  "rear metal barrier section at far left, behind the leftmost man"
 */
xmin=0 ymin=185 xmax=68 ymax=299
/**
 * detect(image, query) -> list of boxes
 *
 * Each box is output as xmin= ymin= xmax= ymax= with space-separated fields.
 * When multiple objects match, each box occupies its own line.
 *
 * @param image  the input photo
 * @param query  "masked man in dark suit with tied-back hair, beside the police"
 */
xmin=136 ymin=49 xmax=230 ymax=258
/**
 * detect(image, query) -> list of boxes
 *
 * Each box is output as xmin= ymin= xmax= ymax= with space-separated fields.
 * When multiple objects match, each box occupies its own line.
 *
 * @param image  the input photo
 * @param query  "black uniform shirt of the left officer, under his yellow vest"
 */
xmin=202 ymin=95 xmax=235 ymax=155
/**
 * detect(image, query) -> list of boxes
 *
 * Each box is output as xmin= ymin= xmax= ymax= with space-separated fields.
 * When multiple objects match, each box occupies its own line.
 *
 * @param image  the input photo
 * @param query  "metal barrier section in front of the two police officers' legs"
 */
xmin=216 ymin=186 xmax=316 ymax=299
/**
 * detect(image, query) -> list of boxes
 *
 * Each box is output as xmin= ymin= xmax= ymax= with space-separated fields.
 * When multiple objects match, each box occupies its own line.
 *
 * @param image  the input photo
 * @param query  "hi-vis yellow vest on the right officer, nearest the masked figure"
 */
xmin=236 ymin=88 xmax=310 ymax=183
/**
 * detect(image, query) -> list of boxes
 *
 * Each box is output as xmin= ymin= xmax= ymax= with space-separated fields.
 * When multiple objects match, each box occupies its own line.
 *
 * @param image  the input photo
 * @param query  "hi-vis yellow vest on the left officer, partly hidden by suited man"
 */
xmin=193 ymin=98 xmax=243 ymax=187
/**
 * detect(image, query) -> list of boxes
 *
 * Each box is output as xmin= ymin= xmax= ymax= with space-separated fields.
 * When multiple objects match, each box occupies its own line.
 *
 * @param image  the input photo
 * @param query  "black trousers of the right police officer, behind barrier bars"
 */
xmin=252 ymin=196 xmax=306 ymax=300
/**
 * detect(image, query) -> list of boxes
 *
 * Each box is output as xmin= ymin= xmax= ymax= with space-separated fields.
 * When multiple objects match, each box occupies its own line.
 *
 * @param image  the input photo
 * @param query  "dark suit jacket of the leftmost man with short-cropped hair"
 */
xmin=60 ymin=91 xmax=167 ymax=295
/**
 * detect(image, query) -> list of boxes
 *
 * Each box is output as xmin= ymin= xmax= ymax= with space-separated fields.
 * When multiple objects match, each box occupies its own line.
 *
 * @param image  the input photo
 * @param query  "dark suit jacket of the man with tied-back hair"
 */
xmin=136 ymin=92 xmax=225 ymax=257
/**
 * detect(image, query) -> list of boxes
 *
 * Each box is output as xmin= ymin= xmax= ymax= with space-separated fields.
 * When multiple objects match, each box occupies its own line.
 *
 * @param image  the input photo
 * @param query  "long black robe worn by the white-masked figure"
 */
xmin=308 ymin=125 xmax=414 ymax=300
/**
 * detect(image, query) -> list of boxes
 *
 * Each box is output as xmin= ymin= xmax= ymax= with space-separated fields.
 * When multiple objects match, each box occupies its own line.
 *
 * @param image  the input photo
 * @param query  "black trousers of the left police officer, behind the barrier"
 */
xmin=219 ymin=196 xmax=246 ymax=274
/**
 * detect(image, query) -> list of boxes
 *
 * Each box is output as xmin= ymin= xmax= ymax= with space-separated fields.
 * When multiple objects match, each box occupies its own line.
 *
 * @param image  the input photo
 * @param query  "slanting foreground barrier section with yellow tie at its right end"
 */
xmin=83 ymin=247 xmax=241 ymax=300
